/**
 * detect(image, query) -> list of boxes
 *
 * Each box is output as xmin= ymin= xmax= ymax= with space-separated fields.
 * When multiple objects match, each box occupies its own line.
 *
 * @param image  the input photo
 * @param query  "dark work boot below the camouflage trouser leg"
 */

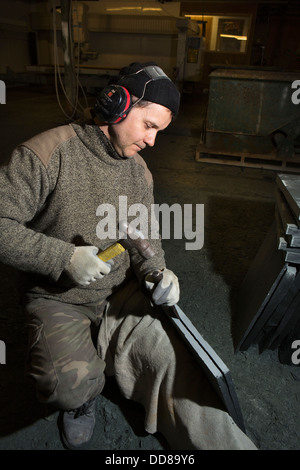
xmin=62 ymin=398 xmax=96 ymax=450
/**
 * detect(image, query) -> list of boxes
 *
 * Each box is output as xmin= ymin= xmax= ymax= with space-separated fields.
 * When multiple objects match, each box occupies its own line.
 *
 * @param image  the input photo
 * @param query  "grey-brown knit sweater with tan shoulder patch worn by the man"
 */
xmin=0 ymin=124 xmax=165 ymax=304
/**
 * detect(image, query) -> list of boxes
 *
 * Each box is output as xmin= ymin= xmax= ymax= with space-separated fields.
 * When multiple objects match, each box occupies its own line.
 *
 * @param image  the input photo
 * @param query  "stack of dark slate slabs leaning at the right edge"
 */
xmin=233 ymin=174 xmax=300 ymax=363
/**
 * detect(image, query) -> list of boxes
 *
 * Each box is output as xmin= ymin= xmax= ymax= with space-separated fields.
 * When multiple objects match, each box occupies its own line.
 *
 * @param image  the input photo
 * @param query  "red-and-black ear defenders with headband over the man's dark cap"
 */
xmin=95 ymin=65 xmax=170 ymax=124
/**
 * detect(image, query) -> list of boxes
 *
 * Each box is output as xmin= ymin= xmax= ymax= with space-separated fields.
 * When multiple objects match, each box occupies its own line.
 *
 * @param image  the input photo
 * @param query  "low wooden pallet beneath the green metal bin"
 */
xmin=195 ymin=142 xmax=300 ymax=173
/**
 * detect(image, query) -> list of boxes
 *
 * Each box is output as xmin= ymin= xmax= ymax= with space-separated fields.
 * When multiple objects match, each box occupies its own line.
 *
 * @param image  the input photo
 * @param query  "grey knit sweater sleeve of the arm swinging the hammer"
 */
xmin=0 ymin=146 xmax=74 ymax=281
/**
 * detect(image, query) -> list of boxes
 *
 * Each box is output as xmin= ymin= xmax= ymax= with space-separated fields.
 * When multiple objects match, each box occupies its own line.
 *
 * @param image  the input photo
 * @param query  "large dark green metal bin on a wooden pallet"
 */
xmin=196 ymin=67 xmax=300 ymax=172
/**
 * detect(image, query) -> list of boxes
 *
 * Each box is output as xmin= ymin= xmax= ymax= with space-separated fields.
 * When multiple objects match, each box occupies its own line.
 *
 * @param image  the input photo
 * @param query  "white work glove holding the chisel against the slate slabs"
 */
xmin=145 ymin=269 xmax=179 ymax=307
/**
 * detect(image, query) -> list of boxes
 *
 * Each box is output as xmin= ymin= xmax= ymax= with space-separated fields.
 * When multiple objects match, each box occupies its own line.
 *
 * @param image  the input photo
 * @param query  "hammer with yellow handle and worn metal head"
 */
xmin=97 ymin=221 xmax=155 ymax=261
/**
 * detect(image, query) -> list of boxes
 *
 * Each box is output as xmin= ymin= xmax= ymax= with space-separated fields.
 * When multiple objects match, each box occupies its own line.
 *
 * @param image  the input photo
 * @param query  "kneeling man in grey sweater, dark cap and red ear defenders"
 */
xmin=0 ymin=63 xmax=255 ymax=449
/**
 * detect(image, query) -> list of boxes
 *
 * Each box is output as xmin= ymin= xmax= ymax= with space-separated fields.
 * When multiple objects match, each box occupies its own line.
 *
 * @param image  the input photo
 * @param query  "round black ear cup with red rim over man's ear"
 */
xmin=95 ymin=85 xmax=132 ymax=124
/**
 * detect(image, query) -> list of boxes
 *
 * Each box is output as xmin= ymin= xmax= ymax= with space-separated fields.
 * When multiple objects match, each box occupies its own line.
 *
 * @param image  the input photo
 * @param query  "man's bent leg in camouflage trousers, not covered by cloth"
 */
xmin=26 ymin=307 xmax=105 ymax=409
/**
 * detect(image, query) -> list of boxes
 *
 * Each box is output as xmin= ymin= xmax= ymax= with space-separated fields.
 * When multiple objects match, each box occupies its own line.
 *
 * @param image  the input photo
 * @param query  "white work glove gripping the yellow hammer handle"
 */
xmin=66 ymin=246 xmax=111 ymax=286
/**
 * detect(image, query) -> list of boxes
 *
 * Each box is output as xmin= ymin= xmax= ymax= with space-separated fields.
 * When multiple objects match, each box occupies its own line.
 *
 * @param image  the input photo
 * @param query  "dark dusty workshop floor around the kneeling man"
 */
xmin=0 ymin=87 xmax=300 ymax=450
